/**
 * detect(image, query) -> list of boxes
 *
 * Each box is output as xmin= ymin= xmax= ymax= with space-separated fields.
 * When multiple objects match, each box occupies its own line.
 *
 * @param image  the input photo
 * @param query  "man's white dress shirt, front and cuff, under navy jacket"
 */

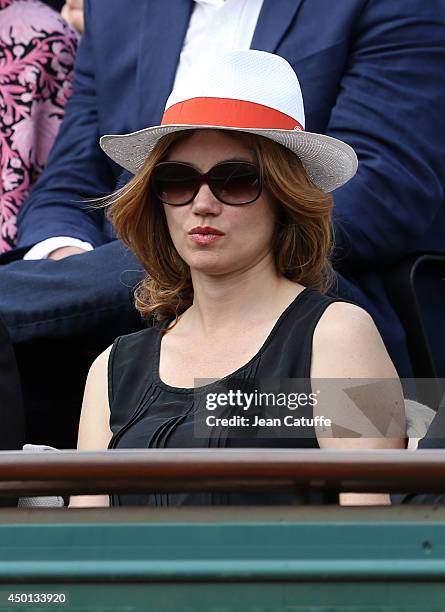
xmin=23 ymin=0 xmax=263 ymax=259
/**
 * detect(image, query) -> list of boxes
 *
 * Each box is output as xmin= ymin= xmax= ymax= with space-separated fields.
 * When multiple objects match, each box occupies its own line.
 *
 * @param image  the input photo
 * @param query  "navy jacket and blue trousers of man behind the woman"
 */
xmin=0 ymin=0 xmax=445 ymax=444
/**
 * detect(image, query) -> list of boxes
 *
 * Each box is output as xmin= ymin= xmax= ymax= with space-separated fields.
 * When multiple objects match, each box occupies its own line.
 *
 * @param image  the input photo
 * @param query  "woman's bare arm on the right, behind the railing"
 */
xmin=311 ymin=302 xmax=406 ymax=505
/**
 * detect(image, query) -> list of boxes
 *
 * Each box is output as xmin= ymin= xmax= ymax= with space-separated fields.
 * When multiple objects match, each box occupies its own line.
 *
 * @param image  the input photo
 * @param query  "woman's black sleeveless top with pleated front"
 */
xmin=108 ymin=288 xmax=340 ymax=506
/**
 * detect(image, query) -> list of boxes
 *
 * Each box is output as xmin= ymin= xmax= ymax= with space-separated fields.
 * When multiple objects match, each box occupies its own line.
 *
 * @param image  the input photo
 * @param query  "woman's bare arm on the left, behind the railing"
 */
xmin=70 ymin=346 xmax=112 ymax=508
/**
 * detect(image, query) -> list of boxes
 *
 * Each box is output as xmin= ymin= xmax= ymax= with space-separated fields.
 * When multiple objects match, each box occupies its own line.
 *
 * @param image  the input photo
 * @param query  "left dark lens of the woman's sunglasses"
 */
xmin=153 ymin=162 xmax=198 ymax=206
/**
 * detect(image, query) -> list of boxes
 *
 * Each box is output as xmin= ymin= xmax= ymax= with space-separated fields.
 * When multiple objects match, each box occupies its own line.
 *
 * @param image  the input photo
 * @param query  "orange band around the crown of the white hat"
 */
xmin=161 ymin=98 xmax=304 ymax=130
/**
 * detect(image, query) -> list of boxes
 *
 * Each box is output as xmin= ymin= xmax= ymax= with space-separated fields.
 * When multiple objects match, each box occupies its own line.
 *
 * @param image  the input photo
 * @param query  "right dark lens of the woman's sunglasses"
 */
xmin=209 ymin=162 xmax=261 ymax=205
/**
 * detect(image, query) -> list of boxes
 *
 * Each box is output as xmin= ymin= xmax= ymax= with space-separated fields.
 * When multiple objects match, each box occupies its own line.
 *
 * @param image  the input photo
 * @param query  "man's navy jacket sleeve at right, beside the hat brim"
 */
xmin=327 ymin=0 xmax=445 ymax=271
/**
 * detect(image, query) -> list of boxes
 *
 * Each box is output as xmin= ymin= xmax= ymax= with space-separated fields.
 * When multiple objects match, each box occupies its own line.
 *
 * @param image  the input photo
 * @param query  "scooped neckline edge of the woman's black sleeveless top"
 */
xmin=153 ymin=287 xmax=313 ymax=394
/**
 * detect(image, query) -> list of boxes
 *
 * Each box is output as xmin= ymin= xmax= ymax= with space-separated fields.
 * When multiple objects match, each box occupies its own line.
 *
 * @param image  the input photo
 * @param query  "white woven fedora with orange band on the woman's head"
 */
xmin=100 ymin=50 xmax=358 ymax=192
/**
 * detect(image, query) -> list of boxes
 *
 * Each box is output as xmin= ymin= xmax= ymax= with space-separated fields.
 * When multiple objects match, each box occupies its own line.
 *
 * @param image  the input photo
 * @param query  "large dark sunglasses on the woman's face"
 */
xmin=150 ymin=161 xmax=263 ymax=206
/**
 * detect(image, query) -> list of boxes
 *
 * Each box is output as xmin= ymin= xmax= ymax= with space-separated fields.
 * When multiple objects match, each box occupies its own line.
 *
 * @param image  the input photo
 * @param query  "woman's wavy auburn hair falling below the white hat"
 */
xmin=107 ymin=130 xmax=333 ymax=323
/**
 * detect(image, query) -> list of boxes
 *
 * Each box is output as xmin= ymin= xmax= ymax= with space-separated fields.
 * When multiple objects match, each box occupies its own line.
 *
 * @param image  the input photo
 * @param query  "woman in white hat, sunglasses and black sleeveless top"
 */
xmin=72 ymin=51 xmax=404 ymax=505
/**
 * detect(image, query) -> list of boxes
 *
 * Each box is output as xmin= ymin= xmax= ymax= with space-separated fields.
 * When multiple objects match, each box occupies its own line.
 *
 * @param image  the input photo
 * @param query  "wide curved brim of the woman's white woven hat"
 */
xmin=100 ymin=125 xmax=358 ymax=193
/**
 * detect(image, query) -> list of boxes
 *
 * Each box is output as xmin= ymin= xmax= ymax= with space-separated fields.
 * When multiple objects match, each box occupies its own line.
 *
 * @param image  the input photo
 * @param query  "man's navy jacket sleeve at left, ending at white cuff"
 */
xmin=18 ymin=0 xmax=114 ymax=247
